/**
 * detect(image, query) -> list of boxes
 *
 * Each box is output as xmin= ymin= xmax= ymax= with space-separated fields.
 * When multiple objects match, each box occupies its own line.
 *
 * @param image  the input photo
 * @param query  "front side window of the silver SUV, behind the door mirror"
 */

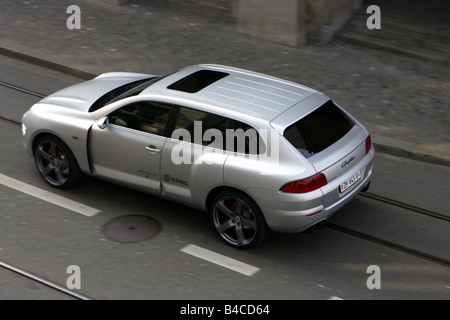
xmin=109 ymin=102 xmax=172 ymax=135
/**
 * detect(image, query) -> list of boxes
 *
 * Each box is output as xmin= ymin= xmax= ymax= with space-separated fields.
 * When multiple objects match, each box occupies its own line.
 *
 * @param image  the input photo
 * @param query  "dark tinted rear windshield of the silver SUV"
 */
xmin=284 ymin=100 xmax=354 ymax=158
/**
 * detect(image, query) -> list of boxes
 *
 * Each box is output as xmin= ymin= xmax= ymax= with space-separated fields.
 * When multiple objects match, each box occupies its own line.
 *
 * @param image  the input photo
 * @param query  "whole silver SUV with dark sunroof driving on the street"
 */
xmin=23 ymin=65 xmax=374 ymax=248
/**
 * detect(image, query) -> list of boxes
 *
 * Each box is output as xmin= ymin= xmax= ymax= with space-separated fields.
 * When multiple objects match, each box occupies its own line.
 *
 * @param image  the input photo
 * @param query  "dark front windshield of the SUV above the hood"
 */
xmin=89 ymin=77 xmax=162 ymax=112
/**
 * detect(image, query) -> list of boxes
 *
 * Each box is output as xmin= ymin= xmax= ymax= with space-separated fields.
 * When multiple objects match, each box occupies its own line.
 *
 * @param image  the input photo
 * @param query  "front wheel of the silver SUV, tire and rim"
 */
xmin=34 ymin=135 xmax=82 ymax=189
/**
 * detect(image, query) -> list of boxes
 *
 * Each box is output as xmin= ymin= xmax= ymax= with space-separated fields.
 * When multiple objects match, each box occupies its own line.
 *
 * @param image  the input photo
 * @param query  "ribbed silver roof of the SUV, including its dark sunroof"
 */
xmin=142 ymin=64 xmax=317 ymax=121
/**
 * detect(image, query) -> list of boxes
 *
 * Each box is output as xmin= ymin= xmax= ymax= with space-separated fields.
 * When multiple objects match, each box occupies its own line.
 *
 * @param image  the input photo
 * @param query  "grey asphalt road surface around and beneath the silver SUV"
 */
xmin=0 ymin=56 xmax=450 ymax=300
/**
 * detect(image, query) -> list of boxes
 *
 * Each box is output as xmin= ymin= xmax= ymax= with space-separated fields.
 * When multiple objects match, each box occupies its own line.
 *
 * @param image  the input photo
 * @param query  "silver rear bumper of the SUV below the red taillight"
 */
xmin=248 ymin=148 xmax=374 ymax=233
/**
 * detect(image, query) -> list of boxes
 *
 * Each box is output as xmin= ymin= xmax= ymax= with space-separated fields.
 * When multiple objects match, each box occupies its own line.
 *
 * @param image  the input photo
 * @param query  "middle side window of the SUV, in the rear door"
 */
xmin=172 ymin=107 xmax=227 ymax=149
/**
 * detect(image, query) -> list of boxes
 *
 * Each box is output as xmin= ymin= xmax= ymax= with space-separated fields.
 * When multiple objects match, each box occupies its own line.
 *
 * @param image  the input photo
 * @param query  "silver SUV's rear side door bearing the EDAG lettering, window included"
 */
xmin=161 ymin=106 xmax=228 ymax=207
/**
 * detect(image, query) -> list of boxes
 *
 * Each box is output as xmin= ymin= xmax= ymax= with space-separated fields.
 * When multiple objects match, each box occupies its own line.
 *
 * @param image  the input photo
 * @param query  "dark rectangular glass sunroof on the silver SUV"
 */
xmin=167 ymin=70 xmax=229 ymax=93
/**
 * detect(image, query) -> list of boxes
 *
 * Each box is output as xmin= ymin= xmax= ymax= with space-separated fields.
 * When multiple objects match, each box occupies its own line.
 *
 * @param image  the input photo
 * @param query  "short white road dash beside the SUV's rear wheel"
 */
xmin=180 ymin=244 xmax=261 ymax=277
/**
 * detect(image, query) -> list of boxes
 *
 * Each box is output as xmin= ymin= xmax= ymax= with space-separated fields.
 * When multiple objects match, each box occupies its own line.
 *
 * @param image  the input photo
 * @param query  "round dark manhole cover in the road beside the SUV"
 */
xmin=103 ymin=215 xmax=161 ymax=243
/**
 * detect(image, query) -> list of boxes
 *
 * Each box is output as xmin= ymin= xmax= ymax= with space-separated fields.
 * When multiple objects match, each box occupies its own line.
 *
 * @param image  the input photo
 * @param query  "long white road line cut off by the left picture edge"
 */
xmin=0 ymin=173 xmax=101 ymax=217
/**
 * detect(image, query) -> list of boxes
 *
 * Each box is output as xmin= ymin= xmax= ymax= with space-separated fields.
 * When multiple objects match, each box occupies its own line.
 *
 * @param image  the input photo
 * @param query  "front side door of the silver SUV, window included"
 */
xmin=89 ymin=101 xmax=172 ymax=195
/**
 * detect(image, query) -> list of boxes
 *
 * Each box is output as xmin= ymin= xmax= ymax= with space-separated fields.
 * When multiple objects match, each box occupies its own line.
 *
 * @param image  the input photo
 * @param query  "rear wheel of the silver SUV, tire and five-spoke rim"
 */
xmin=210 ymin=190 xmax=269 ymax=249
